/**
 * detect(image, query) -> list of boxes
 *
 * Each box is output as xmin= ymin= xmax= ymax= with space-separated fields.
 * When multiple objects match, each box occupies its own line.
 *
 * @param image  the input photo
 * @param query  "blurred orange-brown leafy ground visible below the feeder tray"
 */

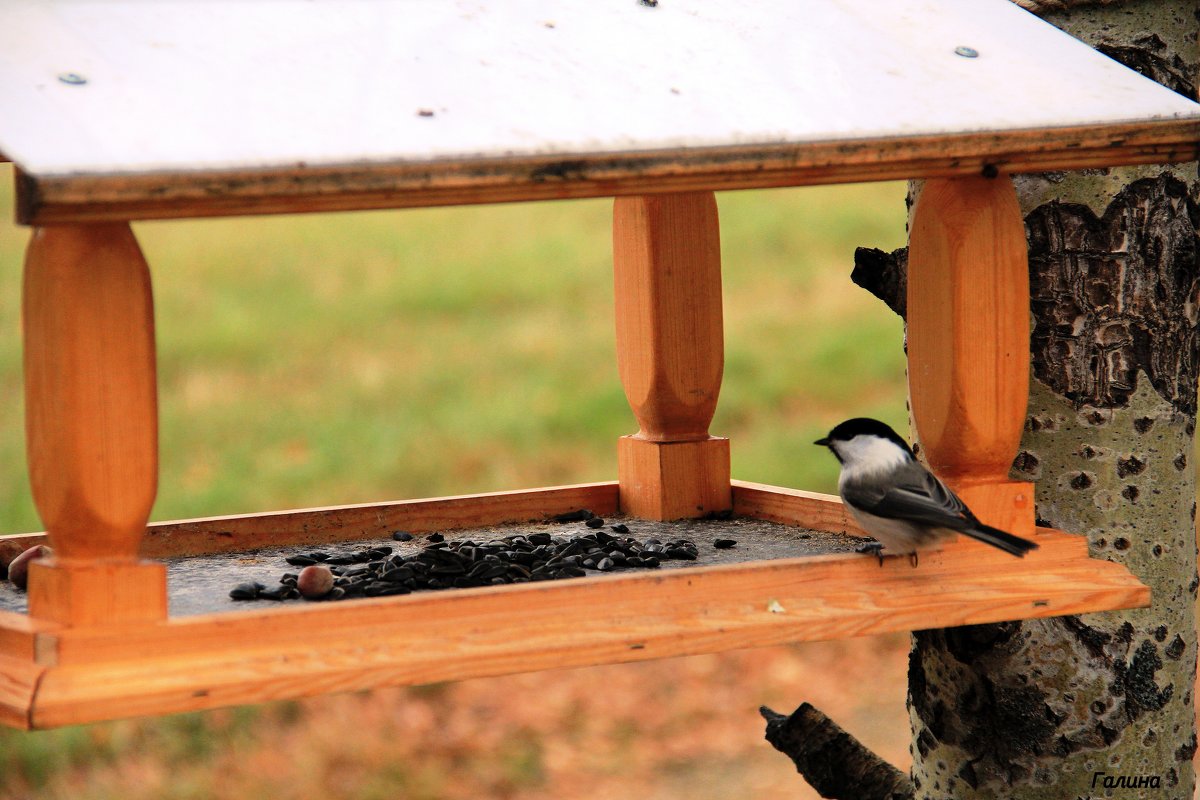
xmin=0 ymin=636 xmax=908 ymax=800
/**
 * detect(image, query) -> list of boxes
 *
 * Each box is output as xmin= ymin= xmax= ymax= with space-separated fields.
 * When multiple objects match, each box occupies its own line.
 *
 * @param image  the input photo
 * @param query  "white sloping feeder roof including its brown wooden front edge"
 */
xmin=0 ymin=0 xmax=1200 ymax=221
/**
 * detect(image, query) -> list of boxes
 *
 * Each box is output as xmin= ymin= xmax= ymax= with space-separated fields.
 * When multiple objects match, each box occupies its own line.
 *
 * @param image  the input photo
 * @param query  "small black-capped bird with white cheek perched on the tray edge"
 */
xmin=812 ymin=417 xmax=1037 ymax=564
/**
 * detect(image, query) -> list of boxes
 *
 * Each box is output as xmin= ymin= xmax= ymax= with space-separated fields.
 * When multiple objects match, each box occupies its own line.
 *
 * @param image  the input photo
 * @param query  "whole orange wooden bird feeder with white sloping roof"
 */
xmin=0 ymin=0 xmax=1200 ymax=728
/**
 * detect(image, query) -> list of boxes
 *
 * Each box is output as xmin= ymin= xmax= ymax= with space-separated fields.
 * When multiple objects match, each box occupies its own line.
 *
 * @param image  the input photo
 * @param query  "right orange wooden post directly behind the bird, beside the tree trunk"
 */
xmin=908 ymin=176 xmax=1033 ymax=536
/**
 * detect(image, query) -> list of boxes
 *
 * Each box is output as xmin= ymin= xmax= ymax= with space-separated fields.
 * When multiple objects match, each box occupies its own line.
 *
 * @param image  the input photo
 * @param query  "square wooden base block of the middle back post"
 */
xmin=617 ymin=435 xmax=733 ymax=521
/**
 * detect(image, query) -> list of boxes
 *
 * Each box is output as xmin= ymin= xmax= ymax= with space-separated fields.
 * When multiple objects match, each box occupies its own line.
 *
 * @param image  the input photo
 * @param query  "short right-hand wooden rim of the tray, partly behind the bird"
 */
xmin=731 ymin=480 xmax=1088 ymax=561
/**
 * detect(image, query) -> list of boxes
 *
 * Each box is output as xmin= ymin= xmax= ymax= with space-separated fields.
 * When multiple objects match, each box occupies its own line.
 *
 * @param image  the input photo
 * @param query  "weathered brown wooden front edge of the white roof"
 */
xmin=17 ymin=119 xmax=1200 ymax=224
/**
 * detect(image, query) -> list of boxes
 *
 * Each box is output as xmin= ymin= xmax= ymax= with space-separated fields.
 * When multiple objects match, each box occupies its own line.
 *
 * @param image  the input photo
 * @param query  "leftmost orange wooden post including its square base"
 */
xmin=23 ymin=223 xmax=167 ymax=625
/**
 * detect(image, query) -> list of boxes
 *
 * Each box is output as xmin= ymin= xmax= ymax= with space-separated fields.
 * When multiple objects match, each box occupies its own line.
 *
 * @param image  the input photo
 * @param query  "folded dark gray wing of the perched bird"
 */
xmin=841 ymin=463 xmax=976 ymax=530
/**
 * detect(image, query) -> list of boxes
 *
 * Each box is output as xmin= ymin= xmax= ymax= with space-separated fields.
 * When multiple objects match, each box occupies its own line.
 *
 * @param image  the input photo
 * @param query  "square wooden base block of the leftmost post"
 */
xmin=29 ymin=560 xmax=167 ymax=626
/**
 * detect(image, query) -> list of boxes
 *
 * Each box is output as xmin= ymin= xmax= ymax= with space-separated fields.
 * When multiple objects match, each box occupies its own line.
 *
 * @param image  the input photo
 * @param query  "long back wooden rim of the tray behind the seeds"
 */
xmin=0 ymin=481 xmax=618 ymax=564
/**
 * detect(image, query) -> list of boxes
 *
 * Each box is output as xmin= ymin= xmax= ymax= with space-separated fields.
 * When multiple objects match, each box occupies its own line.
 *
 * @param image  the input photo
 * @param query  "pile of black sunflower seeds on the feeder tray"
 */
xmin=229 ymin=510 xmax=736 ymax=600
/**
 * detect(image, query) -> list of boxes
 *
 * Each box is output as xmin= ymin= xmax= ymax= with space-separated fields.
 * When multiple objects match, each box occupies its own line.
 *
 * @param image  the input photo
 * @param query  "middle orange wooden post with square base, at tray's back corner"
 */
xmin=613 ymin=192 xmax=732 ymax=519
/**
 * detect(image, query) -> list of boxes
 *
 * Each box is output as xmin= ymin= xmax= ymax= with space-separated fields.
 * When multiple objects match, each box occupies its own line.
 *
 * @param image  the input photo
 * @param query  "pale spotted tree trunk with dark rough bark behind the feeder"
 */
xmin=763 ymin=0 xmax=1200 ymax=800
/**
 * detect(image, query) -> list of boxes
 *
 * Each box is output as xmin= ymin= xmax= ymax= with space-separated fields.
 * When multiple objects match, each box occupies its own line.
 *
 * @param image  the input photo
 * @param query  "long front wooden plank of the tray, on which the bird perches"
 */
xmin=31 ymin=561 xmax=1148 ymax=728
